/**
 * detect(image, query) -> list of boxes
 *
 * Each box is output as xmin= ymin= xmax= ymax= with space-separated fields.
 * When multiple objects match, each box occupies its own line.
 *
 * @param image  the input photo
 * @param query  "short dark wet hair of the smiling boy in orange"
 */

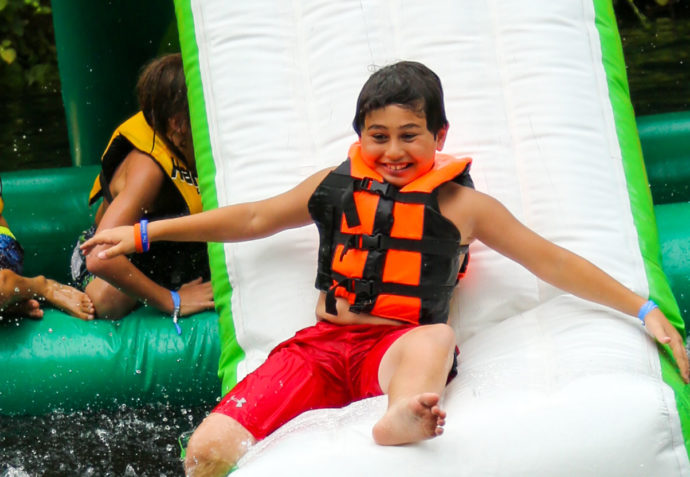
xmin=352 ymin=61 xmax=448 ymax=137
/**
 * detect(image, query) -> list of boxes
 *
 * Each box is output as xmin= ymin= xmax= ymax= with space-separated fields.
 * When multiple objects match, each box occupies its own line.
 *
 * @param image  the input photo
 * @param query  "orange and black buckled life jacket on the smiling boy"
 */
xmin=309 ymin=143 xmax=473 ymax=324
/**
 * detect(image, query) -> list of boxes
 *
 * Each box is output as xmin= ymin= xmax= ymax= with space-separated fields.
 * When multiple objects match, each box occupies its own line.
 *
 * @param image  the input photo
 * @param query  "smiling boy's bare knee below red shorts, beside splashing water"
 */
xmin=184 ymin=412 xmax=256 ymax=477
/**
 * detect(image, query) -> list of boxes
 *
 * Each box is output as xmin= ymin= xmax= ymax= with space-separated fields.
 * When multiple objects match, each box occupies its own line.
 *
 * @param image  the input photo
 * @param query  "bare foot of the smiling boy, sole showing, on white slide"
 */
xmin=372 ymin=393 xmax=446 ymax=446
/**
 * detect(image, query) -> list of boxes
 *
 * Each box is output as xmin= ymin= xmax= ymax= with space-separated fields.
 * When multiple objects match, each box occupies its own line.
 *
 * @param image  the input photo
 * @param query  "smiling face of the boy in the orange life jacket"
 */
xmin=360 ymin=104 xmax=448 ymax=187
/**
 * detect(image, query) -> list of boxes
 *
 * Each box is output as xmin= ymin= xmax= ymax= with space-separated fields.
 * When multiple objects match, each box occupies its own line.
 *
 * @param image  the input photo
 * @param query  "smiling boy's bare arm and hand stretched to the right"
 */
xmin=454 ymin=189 xmax=690 ymax=383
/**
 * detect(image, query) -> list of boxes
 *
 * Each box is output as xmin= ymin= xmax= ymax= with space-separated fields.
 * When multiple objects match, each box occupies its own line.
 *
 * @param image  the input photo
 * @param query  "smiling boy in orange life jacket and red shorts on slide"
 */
xmin=82 ymin=62 xmax=690 ymax=476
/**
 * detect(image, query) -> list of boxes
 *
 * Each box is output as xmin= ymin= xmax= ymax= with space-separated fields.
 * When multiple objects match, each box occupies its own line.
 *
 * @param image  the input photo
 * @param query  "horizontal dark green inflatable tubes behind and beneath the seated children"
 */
xmin=0 ymin=166 xmax=220 ymax=415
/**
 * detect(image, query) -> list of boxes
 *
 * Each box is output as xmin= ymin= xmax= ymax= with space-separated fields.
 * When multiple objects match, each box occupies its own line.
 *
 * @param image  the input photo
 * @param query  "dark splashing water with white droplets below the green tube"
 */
xmin=0 ymin=404 xmax=213 ymax=477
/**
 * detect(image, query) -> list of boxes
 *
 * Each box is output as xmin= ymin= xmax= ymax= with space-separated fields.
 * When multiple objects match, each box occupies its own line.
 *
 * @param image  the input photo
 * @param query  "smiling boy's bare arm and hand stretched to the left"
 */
xmin=81 ymin=169 xmax=330 ymax=258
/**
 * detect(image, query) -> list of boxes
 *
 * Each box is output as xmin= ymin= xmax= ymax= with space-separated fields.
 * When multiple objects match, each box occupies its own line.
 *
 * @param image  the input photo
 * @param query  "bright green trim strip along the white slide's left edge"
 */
xmin=175 ymin=0 xmax=244 ymax=395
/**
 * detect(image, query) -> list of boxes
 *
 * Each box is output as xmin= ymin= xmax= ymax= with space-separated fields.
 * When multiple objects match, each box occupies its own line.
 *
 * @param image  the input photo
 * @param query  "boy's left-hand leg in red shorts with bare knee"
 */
xmin=185 ymin=322 xmax=349 ymax=477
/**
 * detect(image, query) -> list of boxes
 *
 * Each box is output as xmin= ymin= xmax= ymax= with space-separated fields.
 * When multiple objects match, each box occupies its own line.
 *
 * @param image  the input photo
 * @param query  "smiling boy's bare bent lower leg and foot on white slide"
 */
xmin=372 ymin=324 xmax=455 ymax=445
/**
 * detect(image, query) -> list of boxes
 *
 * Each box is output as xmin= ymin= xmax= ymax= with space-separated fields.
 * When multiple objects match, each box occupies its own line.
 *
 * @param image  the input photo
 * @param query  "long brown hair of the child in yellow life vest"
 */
xmin=137 ymin=53 xmax=189 ymax=137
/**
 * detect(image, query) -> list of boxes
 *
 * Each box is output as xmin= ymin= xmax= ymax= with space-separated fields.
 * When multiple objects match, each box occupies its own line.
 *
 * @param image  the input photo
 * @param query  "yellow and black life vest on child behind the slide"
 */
xmin=89 ymin=111 xmax=202 ymax=214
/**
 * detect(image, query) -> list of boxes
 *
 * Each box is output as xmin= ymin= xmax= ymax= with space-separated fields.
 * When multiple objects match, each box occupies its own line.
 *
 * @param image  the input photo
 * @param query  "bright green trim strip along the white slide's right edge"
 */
xmin=594 ymin=0 xmax=690 ymax=457
